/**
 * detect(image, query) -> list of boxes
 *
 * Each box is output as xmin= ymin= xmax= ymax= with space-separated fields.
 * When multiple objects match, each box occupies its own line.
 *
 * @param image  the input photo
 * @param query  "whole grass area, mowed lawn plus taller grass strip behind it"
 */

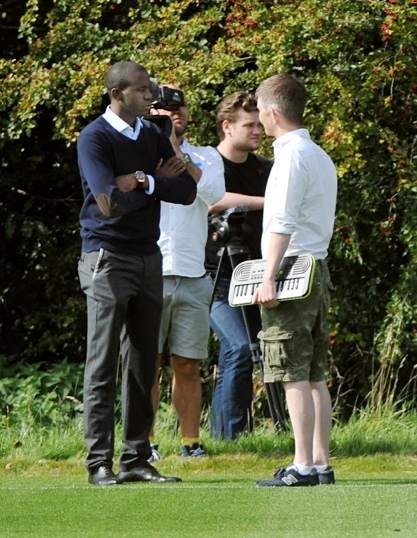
xmin=0 ymin=412 xmax=417 ymax=538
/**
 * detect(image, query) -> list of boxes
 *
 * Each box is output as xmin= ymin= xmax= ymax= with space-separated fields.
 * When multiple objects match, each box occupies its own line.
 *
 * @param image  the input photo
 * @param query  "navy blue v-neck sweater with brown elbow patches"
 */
xmin=77 ymin=116 xmax=196 ymax=255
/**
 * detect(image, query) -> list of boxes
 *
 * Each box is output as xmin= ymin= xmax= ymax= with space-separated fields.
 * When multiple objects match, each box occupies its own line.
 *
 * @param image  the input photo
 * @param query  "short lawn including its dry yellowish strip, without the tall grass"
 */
xmin=0 ymin=454 xmax=417 ymax=538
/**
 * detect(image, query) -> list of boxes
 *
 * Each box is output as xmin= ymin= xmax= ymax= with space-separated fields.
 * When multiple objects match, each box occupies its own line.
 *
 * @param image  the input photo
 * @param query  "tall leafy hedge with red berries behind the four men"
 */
xmin=0 ymin=0 xmax=417 ymax=412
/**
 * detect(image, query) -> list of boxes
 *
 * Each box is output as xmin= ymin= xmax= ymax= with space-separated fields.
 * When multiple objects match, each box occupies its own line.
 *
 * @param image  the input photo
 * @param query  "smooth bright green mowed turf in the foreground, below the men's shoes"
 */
xmin=0 ymin=476 xmax=417 ymax=538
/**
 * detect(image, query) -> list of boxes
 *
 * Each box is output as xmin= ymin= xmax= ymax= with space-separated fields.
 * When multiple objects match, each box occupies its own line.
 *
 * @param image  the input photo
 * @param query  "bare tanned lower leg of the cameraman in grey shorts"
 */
xmin=172 ymin=355 xmax=202 ymax=438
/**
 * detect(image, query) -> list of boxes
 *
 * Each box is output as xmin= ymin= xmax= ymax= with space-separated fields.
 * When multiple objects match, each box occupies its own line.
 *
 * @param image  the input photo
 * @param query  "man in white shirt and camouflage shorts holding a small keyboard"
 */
xmin=254 ymin=75 xmax=337 ymax=487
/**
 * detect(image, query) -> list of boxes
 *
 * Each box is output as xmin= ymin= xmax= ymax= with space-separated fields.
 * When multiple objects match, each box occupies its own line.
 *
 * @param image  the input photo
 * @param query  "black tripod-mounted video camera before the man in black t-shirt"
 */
xmin=208 ymin=206 xmax=250 ymax=243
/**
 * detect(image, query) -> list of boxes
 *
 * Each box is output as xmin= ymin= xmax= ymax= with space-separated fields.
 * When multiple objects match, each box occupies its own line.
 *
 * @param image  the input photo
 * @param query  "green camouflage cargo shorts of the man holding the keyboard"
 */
xmin=258 ymin=260 xmax=333 ymax=383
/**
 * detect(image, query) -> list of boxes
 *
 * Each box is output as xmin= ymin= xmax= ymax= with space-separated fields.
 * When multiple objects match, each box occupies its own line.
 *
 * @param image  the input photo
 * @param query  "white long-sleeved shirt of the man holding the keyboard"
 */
xmin=262 ymin=129 xmax=337 ymax=259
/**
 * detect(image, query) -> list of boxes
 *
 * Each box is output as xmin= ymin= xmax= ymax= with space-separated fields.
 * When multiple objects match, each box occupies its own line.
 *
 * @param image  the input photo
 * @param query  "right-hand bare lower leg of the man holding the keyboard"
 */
xmin=311 ymin=381 xmax=332 ymax=465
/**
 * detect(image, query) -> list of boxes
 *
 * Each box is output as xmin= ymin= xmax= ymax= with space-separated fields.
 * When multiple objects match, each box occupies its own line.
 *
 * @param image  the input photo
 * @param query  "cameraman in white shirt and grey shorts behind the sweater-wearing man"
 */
xmin=150 ymin=85 xmax=225 ymax=460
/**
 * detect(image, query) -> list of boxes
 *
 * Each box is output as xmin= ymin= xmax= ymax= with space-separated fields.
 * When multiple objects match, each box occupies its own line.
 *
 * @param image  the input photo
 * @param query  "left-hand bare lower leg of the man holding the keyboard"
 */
xmin=283 ymin=381 xmax=315 ymax=466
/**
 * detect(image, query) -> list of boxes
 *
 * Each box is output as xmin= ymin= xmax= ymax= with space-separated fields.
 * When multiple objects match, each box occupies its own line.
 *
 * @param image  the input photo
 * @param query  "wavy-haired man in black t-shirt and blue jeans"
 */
xmin=206 ymin=91 xmax=272 ymax=440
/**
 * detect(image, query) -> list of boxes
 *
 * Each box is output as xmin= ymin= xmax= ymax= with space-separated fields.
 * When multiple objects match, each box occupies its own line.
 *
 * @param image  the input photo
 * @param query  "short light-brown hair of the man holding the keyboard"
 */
xmin=256 ymin=75 xmax=307 ymax=125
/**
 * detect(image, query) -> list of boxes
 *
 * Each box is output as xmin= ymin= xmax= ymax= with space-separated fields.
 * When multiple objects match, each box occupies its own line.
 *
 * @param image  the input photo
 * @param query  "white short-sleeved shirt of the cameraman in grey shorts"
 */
xmin=158 ymin=138 xmax=225 ymax=277
